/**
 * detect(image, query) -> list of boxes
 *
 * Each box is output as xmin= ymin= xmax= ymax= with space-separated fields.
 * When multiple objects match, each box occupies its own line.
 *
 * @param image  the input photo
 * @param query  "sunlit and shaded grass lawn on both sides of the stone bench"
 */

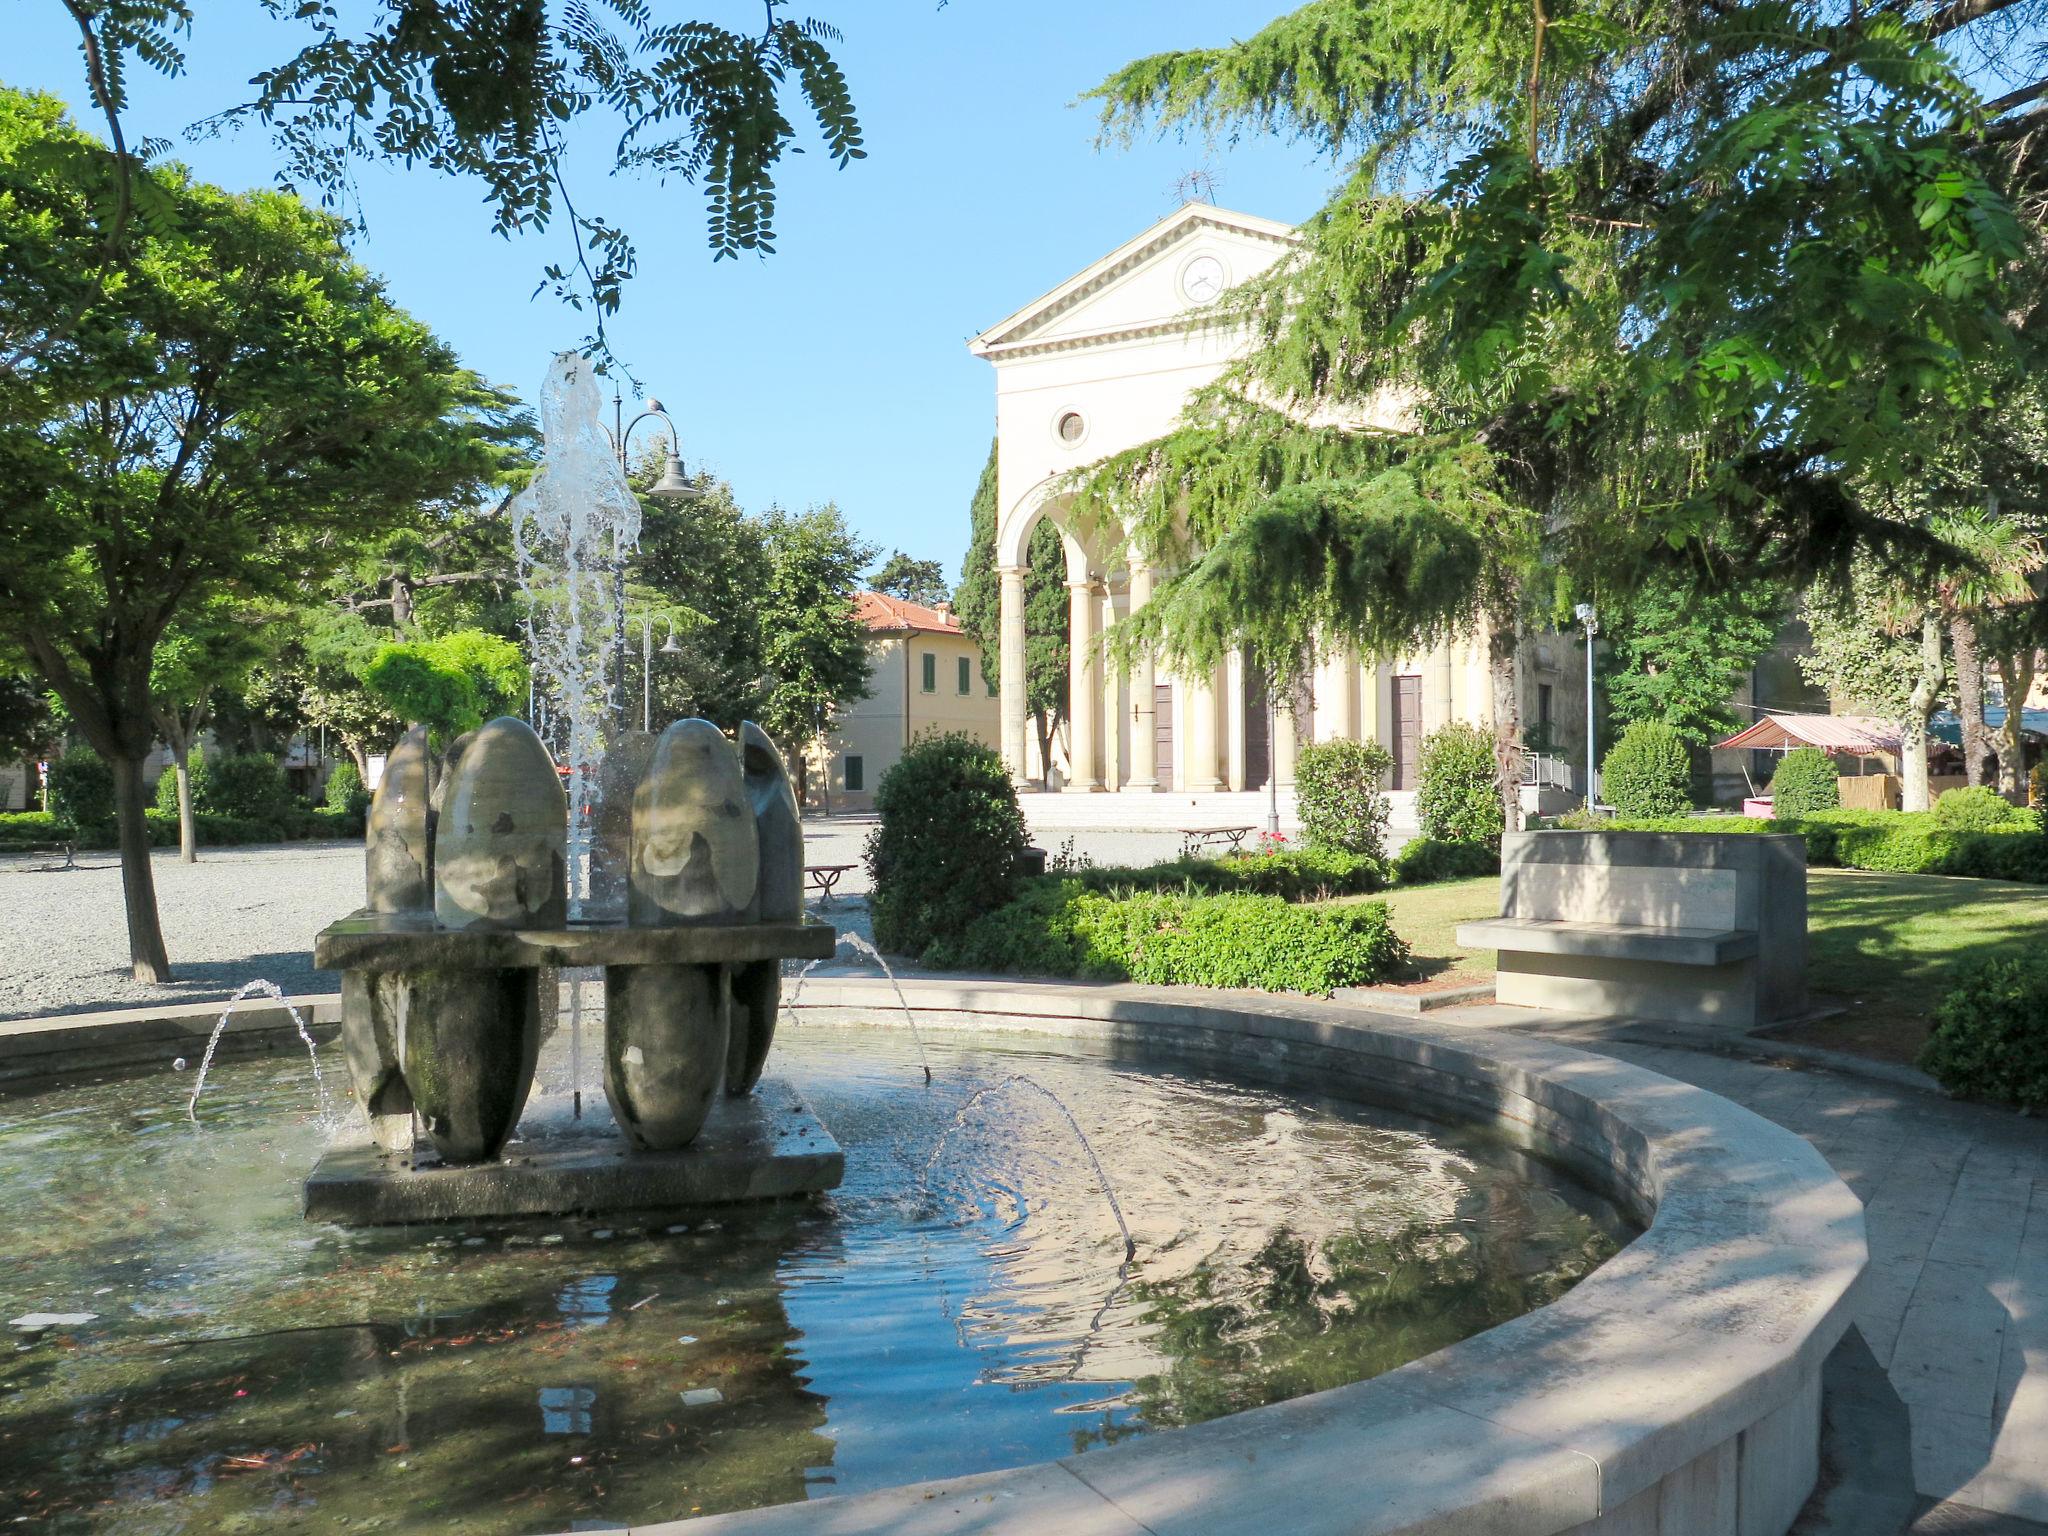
xmin=1370 ymin=868 xmax=2048 ymax=1061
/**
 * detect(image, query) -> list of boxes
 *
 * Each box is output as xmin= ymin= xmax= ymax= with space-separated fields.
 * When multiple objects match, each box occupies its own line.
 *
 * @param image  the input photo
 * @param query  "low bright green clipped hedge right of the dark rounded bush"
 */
xmin=924 ymin=877 xmax=1407 ymax=995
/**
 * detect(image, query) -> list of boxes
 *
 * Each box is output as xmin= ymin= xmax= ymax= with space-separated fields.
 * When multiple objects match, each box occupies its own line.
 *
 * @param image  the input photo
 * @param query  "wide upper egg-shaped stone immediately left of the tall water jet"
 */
xmin=434 ymin=717 xmax=569 ymax=928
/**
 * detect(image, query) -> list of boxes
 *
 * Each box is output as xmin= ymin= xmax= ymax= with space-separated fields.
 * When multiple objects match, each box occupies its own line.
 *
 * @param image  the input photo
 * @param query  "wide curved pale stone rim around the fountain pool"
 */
xmin=0 ymin=977 xmax=1868 ymax=1536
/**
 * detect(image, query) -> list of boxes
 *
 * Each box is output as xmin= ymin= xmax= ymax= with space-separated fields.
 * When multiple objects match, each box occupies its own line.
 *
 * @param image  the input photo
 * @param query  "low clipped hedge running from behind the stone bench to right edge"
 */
xmin=1548 ymin=809 xmax=2048 ymax=885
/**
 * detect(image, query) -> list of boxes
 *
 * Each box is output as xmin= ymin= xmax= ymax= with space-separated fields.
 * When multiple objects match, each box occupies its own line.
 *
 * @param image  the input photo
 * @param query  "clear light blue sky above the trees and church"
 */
xmin=0 ymin=0 xmax=1335 ymax=575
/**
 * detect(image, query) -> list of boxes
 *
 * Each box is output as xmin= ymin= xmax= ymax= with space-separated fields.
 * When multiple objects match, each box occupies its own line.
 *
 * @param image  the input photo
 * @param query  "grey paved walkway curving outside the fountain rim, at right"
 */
xmin=1430 ymin=1006 xmax=2048 ymax=1536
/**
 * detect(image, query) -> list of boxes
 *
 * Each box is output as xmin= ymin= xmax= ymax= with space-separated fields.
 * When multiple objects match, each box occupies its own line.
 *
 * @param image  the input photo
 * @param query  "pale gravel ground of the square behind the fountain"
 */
xmin=0 ymin=815 xmax=1253 ymax=1020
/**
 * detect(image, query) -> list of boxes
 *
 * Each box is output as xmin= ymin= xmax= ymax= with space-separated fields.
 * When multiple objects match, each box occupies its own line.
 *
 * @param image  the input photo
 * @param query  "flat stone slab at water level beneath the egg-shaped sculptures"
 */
xmin=305 ymin=1077 xmax=846 ymax=1227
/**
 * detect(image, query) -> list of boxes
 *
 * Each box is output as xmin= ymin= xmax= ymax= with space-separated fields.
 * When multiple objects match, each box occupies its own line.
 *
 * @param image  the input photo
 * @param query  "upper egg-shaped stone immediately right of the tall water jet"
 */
xmin=627 ymin=719 xmax=760 ymax=928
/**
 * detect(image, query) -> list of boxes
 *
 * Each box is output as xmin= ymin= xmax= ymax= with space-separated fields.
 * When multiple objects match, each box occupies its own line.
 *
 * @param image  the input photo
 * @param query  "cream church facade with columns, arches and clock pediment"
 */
xmin=969 ymin=203 xmax=1585 ymax=797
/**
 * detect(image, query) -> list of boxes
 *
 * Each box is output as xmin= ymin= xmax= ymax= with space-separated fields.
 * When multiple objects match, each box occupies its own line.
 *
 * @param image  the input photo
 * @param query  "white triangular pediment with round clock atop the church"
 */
xmin=969 ymin=203 xmax=1298 ymax=358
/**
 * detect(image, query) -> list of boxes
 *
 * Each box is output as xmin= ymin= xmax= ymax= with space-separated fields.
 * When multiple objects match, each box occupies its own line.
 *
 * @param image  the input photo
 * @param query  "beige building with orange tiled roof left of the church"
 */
xmin=811 ymin=592 xmax=997 ymax=811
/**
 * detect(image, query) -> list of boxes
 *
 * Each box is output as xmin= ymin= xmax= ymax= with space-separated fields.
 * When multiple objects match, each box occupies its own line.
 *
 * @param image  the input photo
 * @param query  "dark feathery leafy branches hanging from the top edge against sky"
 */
xmin=39 ymin=0 xmax=866 ymax=360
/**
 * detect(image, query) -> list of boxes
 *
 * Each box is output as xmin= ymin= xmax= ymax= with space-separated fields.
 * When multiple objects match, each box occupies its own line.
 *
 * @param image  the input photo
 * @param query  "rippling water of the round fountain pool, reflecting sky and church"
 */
xmin=0 ymin=1014 xmax=1632 ymax=1534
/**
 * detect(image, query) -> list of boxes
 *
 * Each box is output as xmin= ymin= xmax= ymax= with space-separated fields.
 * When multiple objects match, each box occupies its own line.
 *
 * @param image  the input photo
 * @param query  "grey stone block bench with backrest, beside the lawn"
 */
xmin=1458 ymin=831 xmax=1806 ymax=1028
